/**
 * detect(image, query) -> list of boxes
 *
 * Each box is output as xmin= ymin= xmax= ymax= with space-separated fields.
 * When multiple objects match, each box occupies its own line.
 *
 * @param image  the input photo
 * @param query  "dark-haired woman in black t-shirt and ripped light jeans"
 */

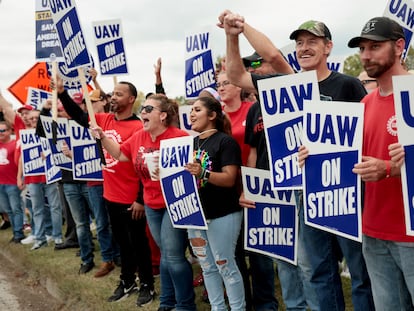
xmin=186 ymin=97 xmax=246 ymax=310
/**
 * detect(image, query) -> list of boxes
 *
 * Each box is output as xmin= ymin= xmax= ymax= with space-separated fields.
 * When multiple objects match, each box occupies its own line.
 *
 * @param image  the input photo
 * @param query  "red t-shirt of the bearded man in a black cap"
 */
xmin=362 ymin=88 xmax=414 ymax=242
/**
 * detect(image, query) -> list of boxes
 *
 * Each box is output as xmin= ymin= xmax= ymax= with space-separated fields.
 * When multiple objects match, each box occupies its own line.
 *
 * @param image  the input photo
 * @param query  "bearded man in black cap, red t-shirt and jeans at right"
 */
xmin=348 ymin=17 xmax=414 ymax=310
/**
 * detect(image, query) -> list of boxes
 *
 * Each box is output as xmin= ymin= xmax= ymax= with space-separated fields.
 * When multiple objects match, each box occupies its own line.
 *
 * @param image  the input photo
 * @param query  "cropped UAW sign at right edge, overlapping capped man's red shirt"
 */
xmin=392 ymin=75 xmax=414 ymax=235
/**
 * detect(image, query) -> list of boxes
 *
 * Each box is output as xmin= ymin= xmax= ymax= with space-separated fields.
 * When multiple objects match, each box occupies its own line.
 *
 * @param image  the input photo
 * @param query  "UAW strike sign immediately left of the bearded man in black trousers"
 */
xmin=69 ymin=120 xmax=103 ymax=181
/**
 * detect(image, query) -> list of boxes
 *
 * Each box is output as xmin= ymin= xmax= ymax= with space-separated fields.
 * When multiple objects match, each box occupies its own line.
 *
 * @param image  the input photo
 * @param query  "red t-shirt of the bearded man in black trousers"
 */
xmin=95 ymin=113 xmax=142 ymax=204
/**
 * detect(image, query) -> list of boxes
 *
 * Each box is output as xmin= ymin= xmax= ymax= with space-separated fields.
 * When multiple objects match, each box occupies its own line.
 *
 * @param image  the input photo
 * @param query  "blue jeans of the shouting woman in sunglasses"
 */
xmin=145 ymin=206 xmax=196 ymax=311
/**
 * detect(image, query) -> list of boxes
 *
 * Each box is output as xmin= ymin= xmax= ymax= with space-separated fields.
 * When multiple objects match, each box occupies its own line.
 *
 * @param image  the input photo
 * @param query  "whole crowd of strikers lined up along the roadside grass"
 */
xmin=0 ymin=11 xmax=414 ymax=311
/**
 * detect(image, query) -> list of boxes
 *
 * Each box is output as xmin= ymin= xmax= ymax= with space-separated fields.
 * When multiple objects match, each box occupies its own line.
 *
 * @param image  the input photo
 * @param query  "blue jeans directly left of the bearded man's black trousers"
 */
xmin=88 ymin=185 xmax=114 ymax=262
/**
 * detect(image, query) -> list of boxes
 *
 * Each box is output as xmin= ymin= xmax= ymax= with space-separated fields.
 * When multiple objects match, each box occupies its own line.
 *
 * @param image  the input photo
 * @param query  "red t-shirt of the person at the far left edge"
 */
xmin=0 ymin=139 xmax=17 ymax=185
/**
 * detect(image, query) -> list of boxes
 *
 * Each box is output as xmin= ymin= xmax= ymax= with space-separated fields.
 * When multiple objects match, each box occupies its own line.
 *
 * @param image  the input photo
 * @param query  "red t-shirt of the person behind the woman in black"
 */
xmin=226 ymin=102 xmax=253 ymax=165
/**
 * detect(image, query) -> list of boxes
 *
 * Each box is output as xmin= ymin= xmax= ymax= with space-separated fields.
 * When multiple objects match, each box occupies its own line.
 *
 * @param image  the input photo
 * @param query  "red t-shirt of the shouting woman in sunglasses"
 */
xmin=121 ymin=126 xmax=188 ymax=209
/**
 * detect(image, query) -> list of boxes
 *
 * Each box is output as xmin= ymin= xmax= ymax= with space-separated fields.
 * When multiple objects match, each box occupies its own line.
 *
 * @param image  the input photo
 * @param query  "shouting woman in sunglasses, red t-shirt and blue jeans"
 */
xmin=94 ymin=94 xmax=196 ymax=311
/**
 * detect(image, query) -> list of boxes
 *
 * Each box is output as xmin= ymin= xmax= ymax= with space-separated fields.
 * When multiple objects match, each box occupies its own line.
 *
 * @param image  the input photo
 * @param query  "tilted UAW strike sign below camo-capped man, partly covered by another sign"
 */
xmin=258 ymin=70 xmax=319 ymax=189
